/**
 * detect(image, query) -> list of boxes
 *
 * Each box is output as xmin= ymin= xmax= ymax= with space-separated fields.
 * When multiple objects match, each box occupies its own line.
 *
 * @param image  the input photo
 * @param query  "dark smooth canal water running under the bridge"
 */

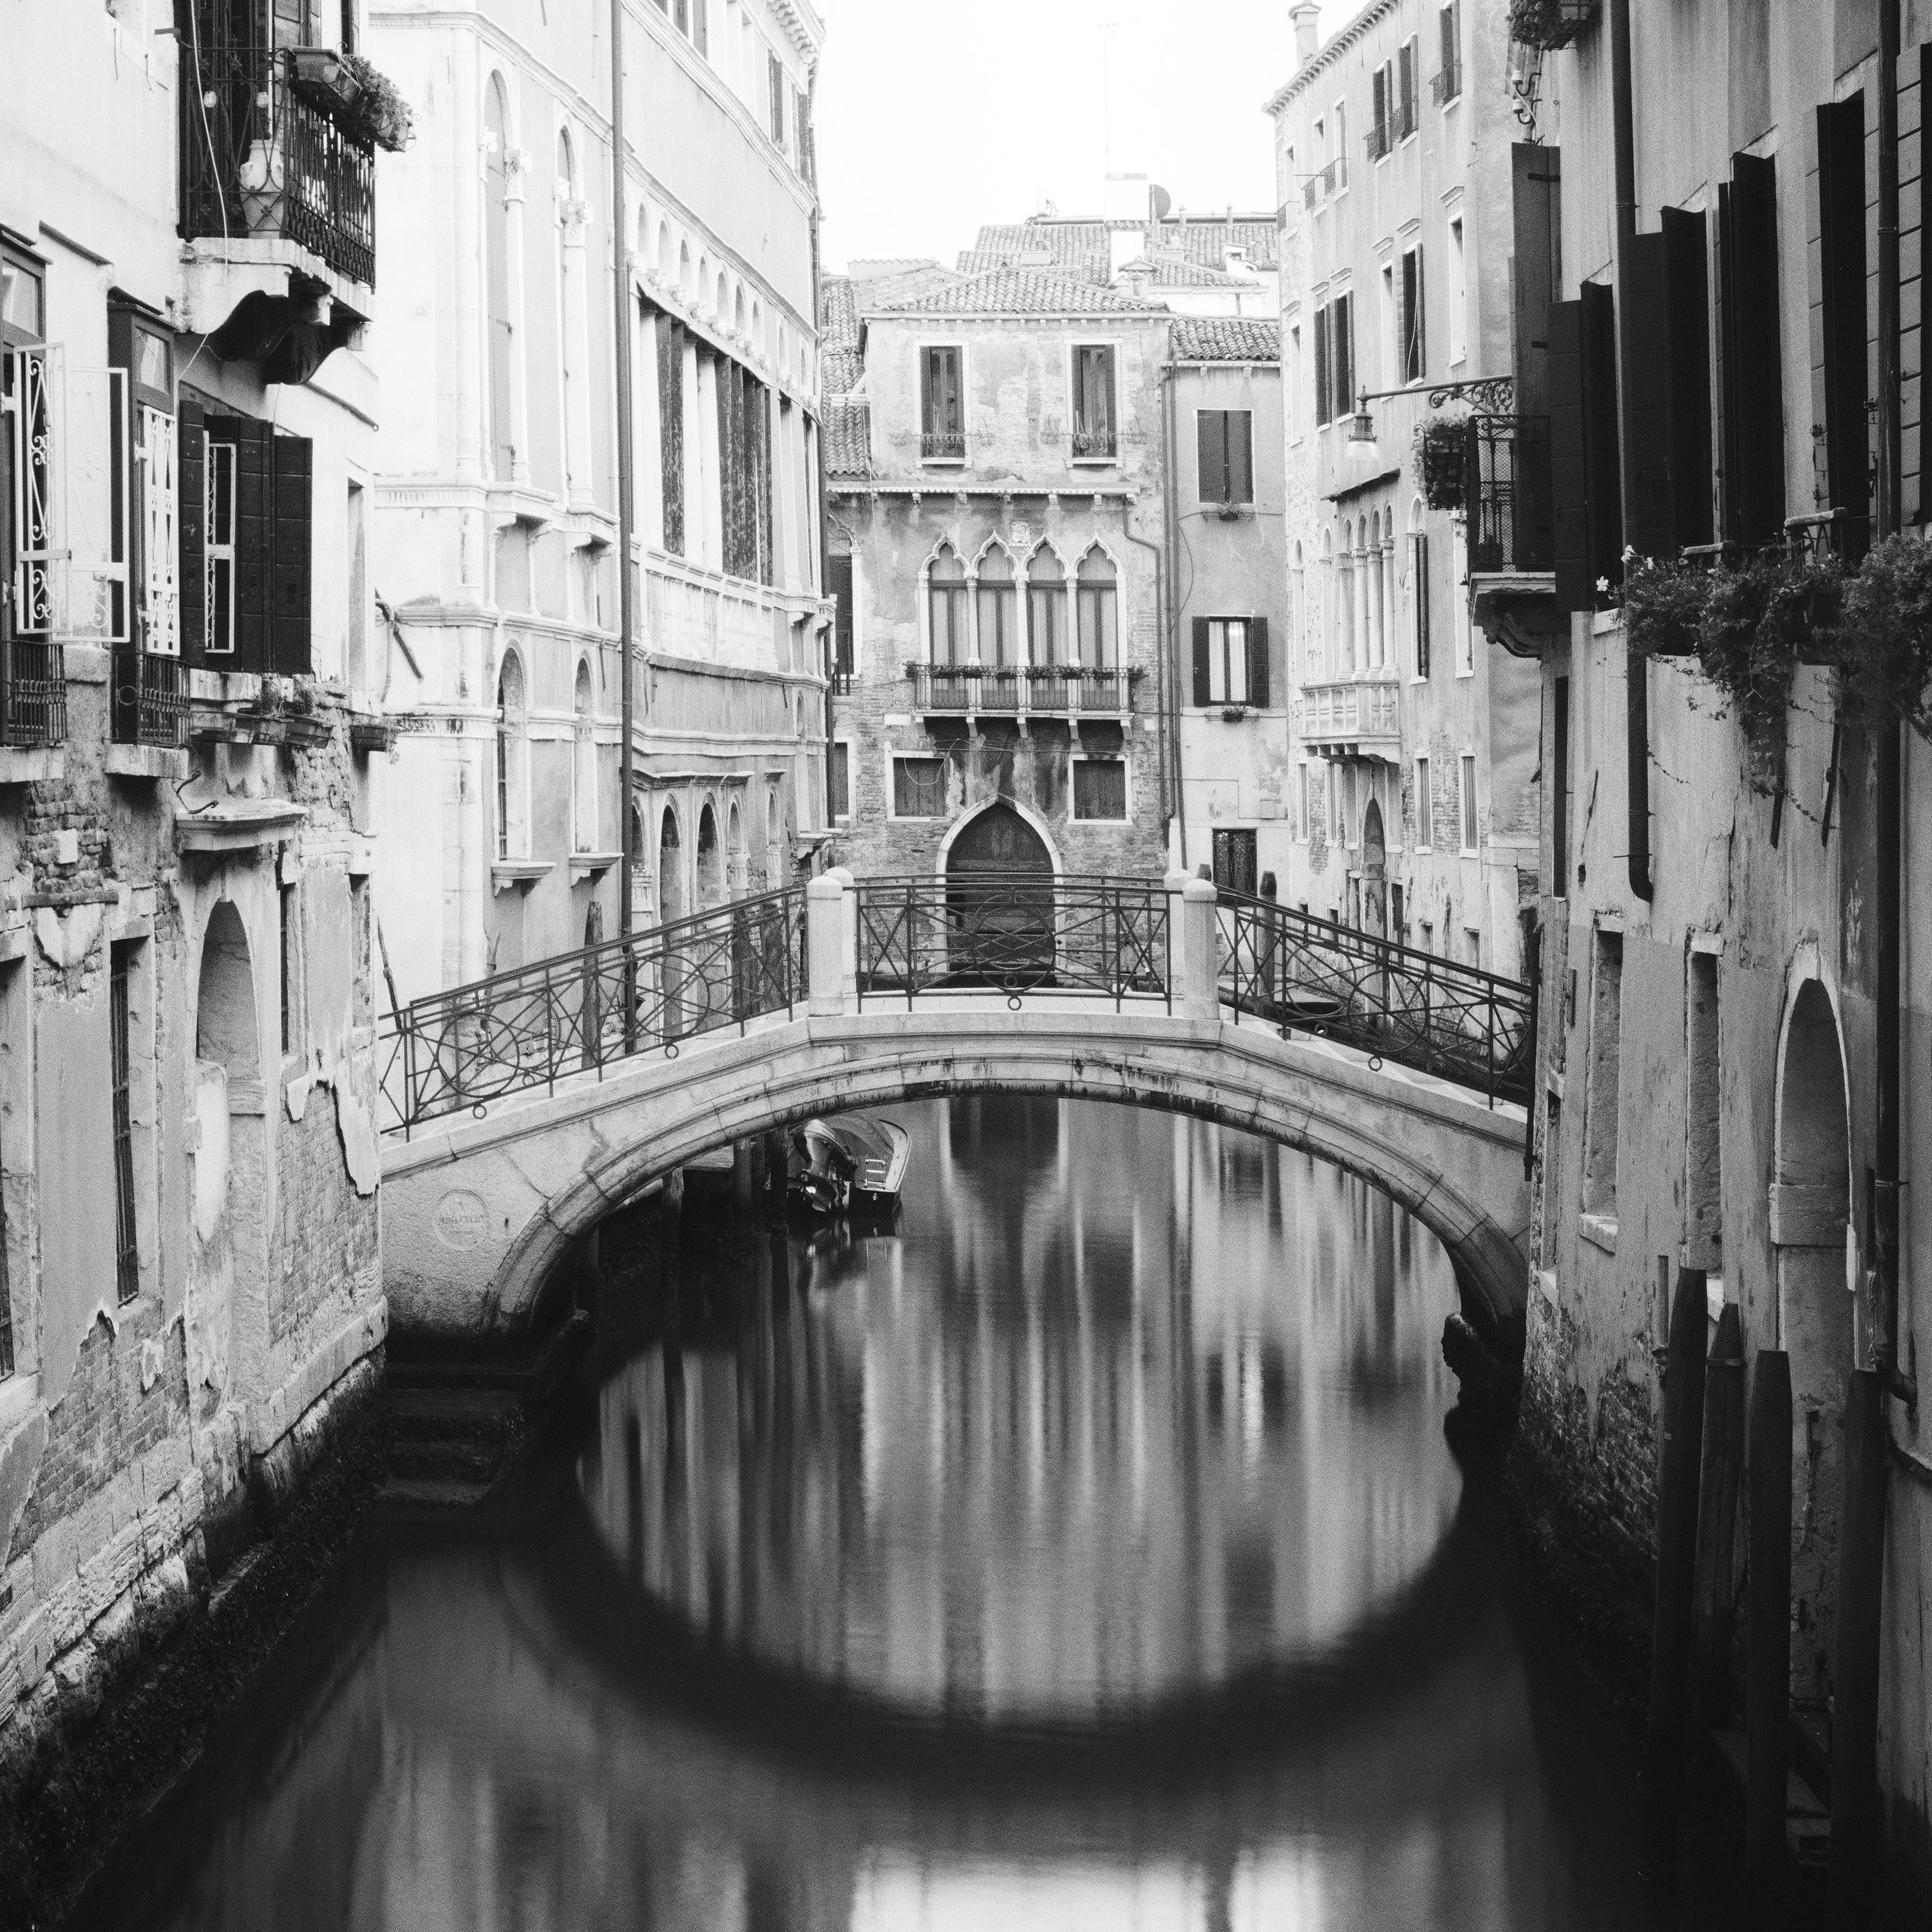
xmin=75 ymin=1097 xmax=1644 ymax=1932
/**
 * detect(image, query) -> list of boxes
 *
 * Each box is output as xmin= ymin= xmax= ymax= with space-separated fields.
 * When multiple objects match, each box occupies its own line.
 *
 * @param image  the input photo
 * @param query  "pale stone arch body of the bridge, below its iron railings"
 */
xmin=383 ymin=997 xmax=1528 ymax=1349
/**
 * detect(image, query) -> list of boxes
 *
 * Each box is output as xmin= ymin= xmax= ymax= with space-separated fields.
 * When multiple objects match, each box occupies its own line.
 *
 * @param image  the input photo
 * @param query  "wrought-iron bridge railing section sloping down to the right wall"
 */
xmin=1217 ymin=891 xmax=1536 ymax=1105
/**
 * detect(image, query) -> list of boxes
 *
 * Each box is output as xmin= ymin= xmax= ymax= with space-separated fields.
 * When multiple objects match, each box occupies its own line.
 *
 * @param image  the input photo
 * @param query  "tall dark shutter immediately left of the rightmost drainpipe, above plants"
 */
xmin=1818 ymin=95 xmax=1872 ymax=558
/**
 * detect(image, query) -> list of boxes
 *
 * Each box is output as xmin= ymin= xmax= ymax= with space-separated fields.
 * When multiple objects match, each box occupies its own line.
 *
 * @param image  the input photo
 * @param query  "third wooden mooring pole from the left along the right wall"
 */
xmin=1745 ymin=1349 xmax=1791 ymax=1886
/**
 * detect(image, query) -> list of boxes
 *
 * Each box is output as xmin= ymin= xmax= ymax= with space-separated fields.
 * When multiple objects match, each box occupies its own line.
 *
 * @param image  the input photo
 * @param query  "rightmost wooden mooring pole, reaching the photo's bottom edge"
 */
xmin=1832 ymin=1368 xmax=1886 ymax=1928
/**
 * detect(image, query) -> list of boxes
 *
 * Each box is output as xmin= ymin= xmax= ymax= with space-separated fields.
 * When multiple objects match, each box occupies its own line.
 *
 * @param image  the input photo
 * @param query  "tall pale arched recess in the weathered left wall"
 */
xmin=187 ymin=898 xmax=269 ymax=1420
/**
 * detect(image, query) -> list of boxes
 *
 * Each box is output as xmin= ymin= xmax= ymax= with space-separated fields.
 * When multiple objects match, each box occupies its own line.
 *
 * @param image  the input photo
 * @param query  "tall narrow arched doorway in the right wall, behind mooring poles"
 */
xmin=1772 ymin=978 xmax=1855 ymax=1700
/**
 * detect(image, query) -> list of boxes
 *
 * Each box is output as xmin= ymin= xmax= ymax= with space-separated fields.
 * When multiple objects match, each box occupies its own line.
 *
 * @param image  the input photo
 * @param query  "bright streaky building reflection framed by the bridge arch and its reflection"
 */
xmin=583 ymin=1095 xmax=1461 ymax=1721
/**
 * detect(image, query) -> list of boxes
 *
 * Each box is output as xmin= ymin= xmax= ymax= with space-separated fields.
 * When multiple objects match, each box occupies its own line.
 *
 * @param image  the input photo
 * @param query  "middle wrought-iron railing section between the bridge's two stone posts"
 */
xmin=856 ymin=871 xmax=1173 ymax=1010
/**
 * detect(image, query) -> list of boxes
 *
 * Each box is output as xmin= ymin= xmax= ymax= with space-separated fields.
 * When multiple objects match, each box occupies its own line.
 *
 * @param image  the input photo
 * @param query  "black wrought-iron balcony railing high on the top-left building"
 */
xmin=180 ymin=39 xmax=375 ymax=288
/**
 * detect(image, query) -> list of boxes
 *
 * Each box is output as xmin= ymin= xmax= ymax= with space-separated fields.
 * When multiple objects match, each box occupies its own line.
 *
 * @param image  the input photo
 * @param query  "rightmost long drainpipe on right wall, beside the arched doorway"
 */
xmin=1870 ymin=0 xmax=1918 ymax=1405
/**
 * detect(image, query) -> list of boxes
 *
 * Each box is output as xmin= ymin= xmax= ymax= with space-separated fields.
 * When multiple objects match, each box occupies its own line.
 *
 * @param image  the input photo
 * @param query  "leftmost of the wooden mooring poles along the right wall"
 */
xmin=1644 ymin=1267 xmax=1710 ymax=1797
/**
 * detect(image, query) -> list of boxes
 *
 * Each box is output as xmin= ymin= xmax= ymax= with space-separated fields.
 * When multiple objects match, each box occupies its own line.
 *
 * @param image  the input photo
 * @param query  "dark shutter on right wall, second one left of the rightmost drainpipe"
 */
xmin=1719 ymin=155 xmax=1785 ymax=545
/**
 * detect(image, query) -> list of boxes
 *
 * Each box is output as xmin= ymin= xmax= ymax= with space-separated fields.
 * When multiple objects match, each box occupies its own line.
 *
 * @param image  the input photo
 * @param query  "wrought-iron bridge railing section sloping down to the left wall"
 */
xmin=381 ymin=887 xmax=806 ymax=1134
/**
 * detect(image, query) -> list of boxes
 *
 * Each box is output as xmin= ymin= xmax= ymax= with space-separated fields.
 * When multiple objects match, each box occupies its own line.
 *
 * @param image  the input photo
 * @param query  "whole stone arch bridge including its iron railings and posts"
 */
xmin=383 ymin=873 xmax=1534 ymax=1352
